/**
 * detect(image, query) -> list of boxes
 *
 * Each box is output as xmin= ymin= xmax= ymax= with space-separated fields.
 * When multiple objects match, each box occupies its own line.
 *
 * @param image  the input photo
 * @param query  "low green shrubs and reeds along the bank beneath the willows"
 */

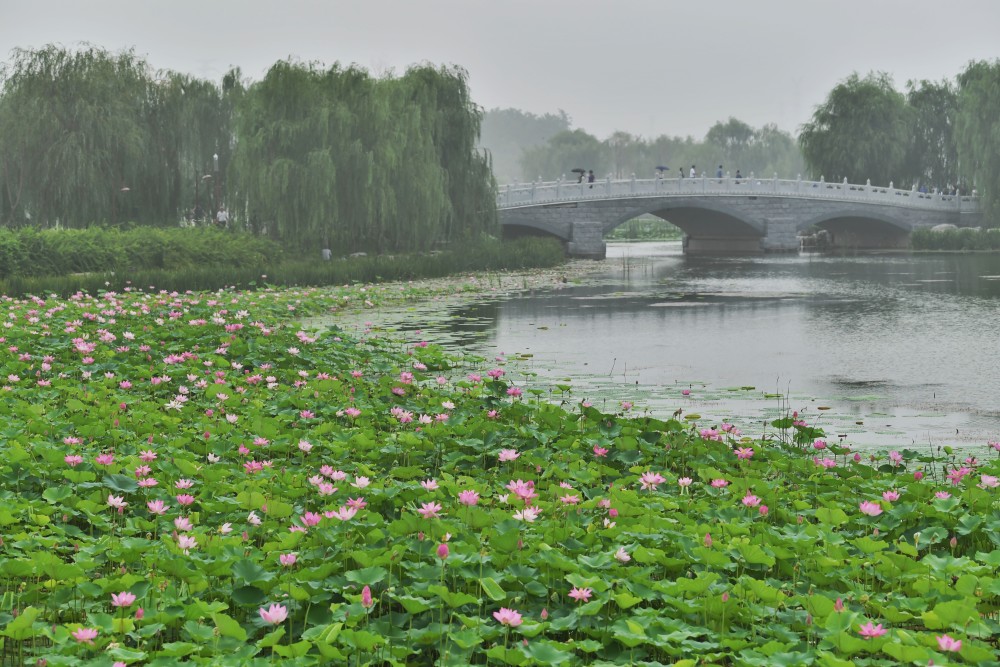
xmin=0 ymin=227 xmax=565 ymax=296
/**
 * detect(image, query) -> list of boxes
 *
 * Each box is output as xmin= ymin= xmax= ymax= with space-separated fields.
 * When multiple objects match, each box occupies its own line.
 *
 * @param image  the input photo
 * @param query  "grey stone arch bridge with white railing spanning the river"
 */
xmin=497 ymin=175 xmax=980 ymax=258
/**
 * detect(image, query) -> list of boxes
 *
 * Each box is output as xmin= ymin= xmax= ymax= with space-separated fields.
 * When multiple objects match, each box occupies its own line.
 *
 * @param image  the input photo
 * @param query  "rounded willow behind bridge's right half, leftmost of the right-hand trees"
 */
xmin=799 ymin=72 xmax=911 ymax=184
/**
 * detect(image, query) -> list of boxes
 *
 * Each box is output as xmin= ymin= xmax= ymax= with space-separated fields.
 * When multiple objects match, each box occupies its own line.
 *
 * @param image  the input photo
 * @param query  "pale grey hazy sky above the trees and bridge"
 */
xmin=0 ymin=0 xmax=1000 ymax=139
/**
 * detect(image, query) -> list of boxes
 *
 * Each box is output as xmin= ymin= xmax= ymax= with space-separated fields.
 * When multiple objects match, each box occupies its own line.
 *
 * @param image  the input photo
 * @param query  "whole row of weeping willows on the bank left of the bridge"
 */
xmin=0 ymin=46 xmax=496 ymax=252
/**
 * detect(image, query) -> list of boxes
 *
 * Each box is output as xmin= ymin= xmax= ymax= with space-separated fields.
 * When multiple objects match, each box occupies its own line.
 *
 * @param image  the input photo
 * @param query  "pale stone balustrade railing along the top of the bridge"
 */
xmin=497 ymin=174 xmax=978 ymax=212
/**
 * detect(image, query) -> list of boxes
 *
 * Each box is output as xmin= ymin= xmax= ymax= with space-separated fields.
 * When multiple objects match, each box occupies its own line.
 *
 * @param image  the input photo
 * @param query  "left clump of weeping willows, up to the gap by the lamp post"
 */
xmin=0 ymin=46 xmax=228 ymax=227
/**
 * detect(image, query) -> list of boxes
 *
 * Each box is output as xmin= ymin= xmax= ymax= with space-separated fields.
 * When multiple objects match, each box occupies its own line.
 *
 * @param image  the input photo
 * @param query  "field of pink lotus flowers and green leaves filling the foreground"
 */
xmin=0 ymin=287 xmax=1000 ymax=667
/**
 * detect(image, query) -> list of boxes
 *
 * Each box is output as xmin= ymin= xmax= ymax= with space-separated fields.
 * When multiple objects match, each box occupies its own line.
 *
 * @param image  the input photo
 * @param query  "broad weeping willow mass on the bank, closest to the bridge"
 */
xmin=232 ymin=61 xmax=496 ymax=252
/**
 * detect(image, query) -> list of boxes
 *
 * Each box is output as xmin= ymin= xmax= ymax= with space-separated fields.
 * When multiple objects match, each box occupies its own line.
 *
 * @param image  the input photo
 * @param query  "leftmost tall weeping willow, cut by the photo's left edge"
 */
xmin=0 ymin=46 xmax=152 ymax=226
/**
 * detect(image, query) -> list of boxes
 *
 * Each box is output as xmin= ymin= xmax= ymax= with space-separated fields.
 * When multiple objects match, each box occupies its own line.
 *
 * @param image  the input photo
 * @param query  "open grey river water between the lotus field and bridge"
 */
xmin=440 ymin=244 xmax=1000 ymax=454
